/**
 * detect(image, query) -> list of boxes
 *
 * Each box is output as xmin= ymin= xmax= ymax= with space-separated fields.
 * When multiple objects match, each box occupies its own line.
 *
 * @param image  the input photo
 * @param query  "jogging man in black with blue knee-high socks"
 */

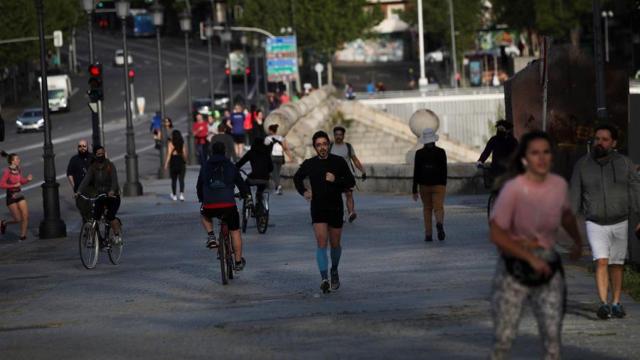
xmin=293 ymin=131 xmax=356 ymax=293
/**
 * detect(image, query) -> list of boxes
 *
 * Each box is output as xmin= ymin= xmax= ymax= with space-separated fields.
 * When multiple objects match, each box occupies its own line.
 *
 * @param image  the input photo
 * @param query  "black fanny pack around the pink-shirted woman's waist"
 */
xmin=502 ymin=249 xmax=563 ymax=287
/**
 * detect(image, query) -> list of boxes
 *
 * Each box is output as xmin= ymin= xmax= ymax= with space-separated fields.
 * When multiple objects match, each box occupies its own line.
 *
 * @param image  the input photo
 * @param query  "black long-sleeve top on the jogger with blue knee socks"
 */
xmin=293 ymin=154 xmax=356 ymax=210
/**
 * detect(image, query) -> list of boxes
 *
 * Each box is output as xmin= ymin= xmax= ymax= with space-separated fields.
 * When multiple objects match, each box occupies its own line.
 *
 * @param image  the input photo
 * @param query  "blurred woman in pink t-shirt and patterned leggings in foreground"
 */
xmin=490 ymin=131 xmax=582 ymax=359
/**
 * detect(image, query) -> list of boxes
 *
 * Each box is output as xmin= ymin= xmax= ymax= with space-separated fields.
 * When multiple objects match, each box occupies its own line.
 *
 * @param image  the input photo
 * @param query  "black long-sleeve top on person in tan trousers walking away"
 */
xmin=413 ymin=145 xmax=447 ymax=194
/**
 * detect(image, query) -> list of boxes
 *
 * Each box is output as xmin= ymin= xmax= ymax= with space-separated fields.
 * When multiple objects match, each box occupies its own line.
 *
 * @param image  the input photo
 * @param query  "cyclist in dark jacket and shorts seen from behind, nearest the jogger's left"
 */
xmin=196 ymin=142 xmax=251 ymax=271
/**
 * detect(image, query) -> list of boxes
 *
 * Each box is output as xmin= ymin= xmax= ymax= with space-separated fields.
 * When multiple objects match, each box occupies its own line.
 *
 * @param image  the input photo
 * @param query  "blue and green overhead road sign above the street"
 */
xmin=266 ymin=36 xmax=299 ymax=82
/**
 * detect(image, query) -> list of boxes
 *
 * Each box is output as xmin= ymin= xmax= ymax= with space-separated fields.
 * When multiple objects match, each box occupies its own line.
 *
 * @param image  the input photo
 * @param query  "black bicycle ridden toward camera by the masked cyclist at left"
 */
xmin=78 ymin=194 xmax=124 ymax=269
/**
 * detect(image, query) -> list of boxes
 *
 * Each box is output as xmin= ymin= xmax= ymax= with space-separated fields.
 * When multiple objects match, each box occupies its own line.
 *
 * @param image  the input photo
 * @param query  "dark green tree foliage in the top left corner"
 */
xmin=0 ymin=0 xmax=85 ymax=67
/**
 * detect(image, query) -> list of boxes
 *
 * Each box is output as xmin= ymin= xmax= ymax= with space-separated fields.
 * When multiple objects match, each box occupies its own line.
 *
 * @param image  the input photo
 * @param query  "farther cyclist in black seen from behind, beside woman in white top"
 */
xmin=236 ymin=138 xmax=273 ymax=204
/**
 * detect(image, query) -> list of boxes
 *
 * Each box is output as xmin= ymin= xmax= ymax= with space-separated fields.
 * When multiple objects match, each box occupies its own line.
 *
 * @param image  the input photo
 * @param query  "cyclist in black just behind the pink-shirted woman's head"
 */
xmin=476 ymin=119 xmax=518 ymax=179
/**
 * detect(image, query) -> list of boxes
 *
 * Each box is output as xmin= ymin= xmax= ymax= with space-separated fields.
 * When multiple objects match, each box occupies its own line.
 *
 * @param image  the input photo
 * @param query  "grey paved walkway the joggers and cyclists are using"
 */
xmin=0 ymin=171 xmax=640 ymax=359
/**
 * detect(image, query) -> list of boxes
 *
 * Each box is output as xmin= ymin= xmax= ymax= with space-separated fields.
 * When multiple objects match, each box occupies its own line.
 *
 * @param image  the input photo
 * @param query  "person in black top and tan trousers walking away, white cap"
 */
xmin=413 ymin=128 xmax=447 ymax=241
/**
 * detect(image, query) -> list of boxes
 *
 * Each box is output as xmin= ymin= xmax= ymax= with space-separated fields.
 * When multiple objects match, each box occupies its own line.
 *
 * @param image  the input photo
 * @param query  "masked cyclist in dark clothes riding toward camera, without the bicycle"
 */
xmin=75 ymin=146 xmax=122 ymax=245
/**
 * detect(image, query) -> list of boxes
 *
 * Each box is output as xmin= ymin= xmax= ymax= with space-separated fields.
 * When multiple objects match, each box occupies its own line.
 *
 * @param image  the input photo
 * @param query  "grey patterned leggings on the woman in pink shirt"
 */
xmin=491 ymin=259 xmax=566 ymax=359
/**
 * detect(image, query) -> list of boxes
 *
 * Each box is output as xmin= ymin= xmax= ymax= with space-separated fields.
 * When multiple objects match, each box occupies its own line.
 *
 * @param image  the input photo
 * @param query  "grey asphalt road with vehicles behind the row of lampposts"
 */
xmin=0 ymin=31 xmax=260 ymax=234
